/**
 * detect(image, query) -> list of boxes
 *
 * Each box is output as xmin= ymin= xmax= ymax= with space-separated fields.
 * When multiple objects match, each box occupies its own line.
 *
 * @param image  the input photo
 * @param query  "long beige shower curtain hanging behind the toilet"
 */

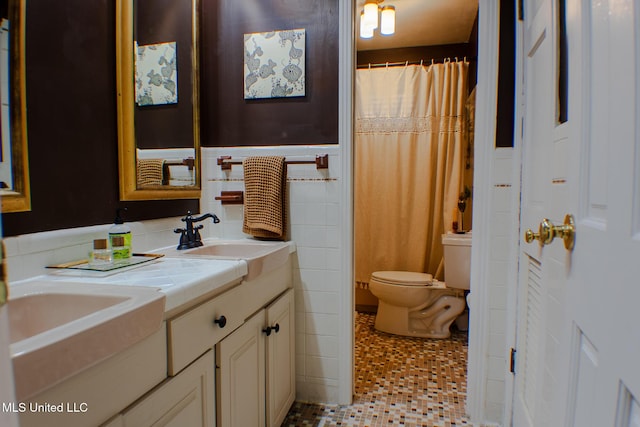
xmin=355 ymin=62 xmax=468 ymax=288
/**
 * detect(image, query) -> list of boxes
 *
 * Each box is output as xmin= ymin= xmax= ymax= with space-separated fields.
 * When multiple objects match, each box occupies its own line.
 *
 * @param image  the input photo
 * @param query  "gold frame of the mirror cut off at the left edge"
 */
xmin=2 ymin=0 xmax=31 ymax=213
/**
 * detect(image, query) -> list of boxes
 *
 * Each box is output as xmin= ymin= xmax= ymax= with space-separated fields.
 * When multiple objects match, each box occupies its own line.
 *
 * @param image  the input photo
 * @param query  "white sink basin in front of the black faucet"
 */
xmin=167 ymin=239 xmax=292 ymax=280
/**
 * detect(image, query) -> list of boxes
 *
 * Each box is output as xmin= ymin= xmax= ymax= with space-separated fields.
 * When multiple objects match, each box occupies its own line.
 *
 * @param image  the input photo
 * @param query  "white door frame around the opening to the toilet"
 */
xmin=338 ymin=0 xmax=520 ymax=422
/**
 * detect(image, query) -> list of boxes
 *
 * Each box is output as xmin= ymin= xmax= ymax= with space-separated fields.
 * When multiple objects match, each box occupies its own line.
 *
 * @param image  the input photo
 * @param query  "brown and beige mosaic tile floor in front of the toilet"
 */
xmin=282 ymin=313 xmax=471 ymax=427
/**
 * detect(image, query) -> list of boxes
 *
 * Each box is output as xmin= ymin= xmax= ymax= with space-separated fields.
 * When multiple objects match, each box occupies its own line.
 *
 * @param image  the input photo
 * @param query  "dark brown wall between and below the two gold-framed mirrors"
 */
xmin=2 ymin=0 xmax=199 ymax=236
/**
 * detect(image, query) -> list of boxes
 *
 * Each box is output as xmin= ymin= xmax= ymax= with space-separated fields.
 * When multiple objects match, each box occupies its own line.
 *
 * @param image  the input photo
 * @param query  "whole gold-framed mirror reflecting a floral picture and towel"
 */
xmin=116 ymin=0 xmax=201 ymax=200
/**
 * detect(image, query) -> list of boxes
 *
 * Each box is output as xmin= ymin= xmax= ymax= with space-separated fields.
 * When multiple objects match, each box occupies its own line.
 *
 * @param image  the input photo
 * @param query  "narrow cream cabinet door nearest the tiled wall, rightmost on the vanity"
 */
xmin=266 ymin=289 xmax=296 ymax=427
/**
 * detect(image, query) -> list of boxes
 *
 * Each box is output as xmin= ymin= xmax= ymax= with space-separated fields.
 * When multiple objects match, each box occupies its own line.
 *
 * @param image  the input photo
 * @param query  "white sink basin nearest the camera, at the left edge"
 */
xmin=7 ymin=280 xmax=165 ymax=400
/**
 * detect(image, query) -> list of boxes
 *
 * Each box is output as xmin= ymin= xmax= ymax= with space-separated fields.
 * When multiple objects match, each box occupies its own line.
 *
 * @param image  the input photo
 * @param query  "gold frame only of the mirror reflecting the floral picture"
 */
xmin=116 ymin=0 xmax=202 ymax=200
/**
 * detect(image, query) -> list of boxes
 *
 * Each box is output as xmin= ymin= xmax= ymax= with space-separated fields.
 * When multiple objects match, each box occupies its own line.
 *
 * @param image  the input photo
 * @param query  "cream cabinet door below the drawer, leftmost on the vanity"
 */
xmin=117 ymin=350 xmax=215 ymax=427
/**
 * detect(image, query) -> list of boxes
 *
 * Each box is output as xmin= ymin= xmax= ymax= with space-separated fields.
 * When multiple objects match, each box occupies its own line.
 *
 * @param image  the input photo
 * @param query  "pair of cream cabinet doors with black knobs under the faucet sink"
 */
xmin=216 ymin=289 xmax=295 ymax=427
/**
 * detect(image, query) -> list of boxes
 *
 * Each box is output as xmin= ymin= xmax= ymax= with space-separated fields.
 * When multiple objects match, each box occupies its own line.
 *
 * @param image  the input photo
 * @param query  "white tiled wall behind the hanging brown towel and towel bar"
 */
xmin=200 ymin=144 xmax=348 ymax=403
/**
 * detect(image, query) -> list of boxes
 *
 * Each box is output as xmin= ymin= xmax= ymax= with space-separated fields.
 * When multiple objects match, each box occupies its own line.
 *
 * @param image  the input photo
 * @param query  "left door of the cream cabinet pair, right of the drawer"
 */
xmin=216 ymin=310 xmax=265 ymax=427
